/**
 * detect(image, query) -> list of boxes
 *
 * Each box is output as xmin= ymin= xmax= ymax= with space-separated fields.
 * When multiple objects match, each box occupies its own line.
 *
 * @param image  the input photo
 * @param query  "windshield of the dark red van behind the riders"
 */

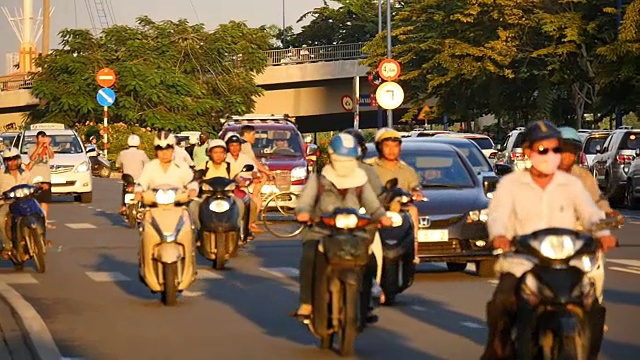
xmin=253 ymin=129 xmax=302 ymax=157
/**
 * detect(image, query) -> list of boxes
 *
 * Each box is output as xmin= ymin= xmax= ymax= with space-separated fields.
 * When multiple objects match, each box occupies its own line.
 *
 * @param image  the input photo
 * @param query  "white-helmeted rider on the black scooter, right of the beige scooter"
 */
xmin=189 ymin=139 xmax=244 ymax=232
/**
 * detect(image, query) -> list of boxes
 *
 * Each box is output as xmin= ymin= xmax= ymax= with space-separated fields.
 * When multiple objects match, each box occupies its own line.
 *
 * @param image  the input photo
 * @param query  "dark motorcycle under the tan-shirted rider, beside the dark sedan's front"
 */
xmin=378 ymin=178 xmax=416 ymax=305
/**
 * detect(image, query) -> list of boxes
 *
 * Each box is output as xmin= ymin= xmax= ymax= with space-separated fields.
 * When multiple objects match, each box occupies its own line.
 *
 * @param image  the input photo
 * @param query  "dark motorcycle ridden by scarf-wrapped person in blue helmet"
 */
xmin=303 ymin=208 xmax=371 ymax=356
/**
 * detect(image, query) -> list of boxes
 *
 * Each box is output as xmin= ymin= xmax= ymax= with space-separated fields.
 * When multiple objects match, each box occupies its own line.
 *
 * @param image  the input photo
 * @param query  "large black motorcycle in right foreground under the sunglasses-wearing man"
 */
xmin=496 ymin=219 xmax=616 ymax=360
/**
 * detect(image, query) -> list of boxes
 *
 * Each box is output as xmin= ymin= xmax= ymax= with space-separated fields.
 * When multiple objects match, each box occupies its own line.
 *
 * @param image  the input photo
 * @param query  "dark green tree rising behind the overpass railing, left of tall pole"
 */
xmin=296 ymin=0 xmax=378 ymax=46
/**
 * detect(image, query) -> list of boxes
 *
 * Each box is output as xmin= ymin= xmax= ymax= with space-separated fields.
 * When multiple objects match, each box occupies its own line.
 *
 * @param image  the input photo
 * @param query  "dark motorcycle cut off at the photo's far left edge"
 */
xmin=2 ymin=184 xmax=47 ymax=273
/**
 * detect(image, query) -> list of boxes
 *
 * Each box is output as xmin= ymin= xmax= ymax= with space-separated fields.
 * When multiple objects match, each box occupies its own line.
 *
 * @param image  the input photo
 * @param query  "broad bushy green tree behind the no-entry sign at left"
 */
xmin=30 ymin=17 xmax=269 ymax=131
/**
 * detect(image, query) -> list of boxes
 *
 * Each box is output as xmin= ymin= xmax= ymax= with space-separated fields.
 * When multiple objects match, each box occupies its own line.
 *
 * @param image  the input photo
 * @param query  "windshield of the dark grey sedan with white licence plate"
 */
xmin=400 ymin=151 xmax=474 ymax=188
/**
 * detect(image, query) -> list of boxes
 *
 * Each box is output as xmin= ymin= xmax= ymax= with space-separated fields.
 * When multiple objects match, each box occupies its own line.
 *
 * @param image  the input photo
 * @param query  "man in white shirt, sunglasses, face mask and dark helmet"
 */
xmin=481 ymin=121 xmax=617 ymax=359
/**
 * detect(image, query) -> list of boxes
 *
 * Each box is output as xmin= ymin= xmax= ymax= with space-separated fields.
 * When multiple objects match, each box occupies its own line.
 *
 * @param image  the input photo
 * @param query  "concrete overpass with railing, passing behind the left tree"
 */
xmin=0 ymin=43 xmax=405 ymax=132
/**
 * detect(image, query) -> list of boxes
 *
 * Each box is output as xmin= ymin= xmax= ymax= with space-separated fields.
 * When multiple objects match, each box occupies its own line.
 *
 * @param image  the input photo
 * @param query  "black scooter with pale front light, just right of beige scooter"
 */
xmin=197 ymin=165 xmax=253 ymax=270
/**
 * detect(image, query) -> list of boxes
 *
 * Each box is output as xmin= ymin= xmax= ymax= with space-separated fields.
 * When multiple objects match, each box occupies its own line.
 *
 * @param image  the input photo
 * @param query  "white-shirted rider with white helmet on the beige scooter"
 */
xmin=136 ymin=131 xmax=199 ymax=201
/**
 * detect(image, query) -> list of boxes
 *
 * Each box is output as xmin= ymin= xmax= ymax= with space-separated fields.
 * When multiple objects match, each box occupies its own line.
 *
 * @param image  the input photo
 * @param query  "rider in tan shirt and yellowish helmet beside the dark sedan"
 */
xmin=371 ymin=128 xmax=424 ymax=263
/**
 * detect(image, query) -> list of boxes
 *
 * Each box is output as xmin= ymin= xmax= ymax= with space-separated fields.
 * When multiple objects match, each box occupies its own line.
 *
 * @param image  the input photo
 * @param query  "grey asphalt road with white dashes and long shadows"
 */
xmin=0 ymin=179 xmax=640 ymax=360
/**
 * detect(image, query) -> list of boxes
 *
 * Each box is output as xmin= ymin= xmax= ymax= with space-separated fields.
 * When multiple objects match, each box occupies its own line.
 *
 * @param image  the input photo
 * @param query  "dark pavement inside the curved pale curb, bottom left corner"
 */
xmin=0 ymin=297 xmax=36 ymax=360
